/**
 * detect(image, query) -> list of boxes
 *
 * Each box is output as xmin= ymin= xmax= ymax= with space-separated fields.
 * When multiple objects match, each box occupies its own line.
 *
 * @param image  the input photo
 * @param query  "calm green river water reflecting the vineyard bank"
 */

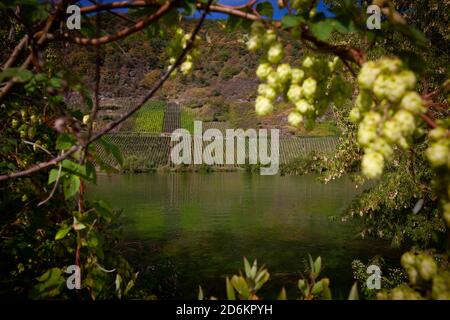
xmin=89 ymin=172 xmax=397 ymax=299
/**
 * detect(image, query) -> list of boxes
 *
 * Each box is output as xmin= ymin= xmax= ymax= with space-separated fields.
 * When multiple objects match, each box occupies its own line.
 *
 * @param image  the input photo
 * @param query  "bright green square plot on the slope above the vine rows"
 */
xmin=133 ymin=100 xmax=166 ymax=133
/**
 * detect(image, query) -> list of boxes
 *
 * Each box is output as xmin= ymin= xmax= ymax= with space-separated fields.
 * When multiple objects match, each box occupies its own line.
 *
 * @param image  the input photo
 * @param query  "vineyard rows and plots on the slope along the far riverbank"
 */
xmin=96 ymin=101 xmax=338 ymax=172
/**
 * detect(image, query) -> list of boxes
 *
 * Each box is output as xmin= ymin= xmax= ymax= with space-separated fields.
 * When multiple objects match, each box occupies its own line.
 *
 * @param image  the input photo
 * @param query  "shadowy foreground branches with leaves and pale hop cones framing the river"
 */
xmin=0 ymin=0 xmax=450 ymax=298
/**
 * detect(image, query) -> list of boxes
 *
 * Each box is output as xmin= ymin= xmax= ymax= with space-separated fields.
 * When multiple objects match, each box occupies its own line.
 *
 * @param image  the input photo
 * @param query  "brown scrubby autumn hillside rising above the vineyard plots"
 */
xmin=63 ymin=18 xmax=338 ymax=136
